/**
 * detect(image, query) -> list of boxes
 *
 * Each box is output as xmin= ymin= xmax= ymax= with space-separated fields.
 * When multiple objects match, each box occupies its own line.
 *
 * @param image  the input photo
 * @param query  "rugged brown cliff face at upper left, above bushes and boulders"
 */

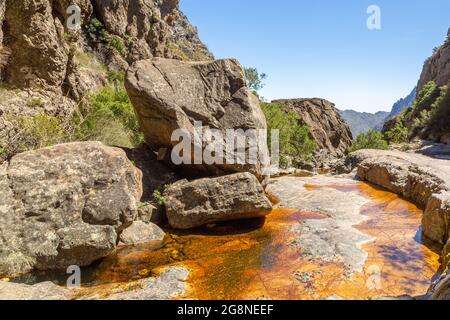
xmin=0 ymin=0 xmax=212 ymax=88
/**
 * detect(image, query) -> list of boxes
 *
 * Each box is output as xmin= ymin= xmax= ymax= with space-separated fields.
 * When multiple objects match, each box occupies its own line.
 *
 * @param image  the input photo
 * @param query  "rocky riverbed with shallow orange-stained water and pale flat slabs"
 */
xmin=0 ymin=176 xmax=441 ymax=299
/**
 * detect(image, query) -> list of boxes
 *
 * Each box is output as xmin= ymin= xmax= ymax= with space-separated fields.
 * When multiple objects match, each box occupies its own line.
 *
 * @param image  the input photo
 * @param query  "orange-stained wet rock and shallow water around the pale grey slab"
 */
xmin=88 ymin=183 xmax=439 ymax=299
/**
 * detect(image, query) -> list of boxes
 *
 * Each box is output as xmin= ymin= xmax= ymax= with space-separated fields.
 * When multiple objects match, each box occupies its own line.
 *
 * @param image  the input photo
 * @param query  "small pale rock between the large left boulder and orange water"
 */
xmin=120 ymin=221 xmax=166 ymax=246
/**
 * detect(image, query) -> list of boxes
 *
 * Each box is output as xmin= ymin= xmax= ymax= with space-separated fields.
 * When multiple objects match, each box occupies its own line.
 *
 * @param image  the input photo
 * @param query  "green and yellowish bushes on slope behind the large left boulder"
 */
xmin=0 ymin=72 xmax=143 ymax=158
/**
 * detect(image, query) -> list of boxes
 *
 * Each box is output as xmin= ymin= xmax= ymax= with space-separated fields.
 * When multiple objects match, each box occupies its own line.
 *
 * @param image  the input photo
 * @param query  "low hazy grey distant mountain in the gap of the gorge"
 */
xmin=340 ymin=110 xmax=390 ymax=137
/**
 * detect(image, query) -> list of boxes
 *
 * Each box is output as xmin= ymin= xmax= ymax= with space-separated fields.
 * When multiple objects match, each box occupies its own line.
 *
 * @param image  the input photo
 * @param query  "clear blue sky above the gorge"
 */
xmin=181 ymin=0 xmax=450 ymax=112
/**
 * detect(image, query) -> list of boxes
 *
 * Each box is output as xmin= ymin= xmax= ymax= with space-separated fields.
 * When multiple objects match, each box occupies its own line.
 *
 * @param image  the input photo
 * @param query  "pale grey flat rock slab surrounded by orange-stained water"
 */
xmin=266 ymin=176 xmax=373 ymax=275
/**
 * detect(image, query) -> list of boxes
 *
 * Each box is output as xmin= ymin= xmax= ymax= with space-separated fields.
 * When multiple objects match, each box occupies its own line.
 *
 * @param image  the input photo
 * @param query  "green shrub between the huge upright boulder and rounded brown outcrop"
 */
xmin=261 ymin=103 xmax=316 ymax=167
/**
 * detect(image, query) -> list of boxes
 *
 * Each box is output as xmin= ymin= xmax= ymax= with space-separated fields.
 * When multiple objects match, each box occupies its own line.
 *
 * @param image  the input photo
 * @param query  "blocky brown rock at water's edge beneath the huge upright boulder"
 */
xmin=164 ymin=173 xmax=272 ymax=229
